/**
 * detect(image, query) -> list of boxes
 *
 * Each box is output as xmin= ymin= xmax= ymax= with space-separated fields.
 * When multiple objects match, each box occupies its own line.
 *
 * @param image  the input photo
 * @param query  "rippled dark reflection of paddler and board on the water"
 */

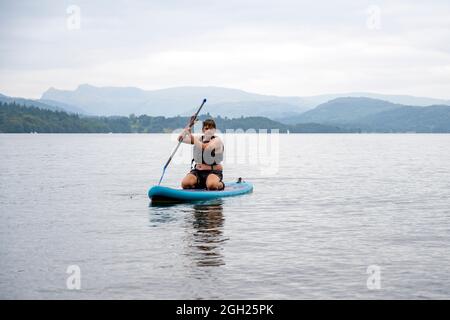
xmin=150 ymin=199 xmax=227 ymax=267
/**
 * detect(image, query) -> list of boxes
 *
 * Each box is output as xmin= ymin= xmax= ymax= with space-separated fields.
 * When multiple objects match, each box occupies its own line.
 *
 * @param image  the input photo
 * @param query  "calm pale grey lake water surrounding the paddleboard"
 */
xmin=0 ymin=134 xmax=450 ymax=299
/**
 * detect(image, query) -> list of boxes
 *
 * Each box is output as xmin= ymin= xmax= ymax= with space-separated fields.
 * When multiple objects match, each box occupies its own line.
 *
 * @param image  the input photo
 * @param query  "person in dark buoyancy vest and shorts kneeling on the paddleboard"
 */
xmin=178 ymin=119 xmax=225 ymax=190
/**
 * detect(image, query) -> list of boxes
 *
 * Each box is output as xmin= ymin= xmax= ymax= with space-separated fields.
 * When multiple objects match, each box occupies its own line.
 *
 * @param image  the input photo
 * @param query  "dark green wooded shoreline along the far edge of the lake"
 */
xmin=0 ymin=102 xmax=351 ymax=133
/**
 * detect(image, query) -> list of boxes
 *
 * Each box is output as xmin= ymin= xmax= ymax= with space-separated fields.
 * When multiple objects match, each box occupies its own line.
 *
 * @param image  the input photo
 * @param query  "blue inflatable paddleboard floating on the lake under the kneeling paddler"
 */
xmin=148 ymin=182 xmax=253 ymax=202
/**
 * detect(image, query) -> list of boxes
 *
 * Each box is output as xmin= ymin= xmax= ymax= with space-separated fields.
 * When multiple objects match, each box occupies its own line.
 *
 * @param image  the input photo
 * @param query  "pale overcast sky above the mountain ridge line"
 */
xmin=0 ymin=0 xmax=450 ymax=99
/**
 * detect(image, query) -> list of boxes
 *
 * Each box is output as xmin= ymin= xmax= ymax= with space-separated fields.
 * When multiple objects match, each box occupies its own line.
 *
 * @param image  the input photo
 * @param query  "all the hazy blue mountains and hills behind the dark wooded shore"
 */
xmin=0 ymin=84 xmax=450 ymax=132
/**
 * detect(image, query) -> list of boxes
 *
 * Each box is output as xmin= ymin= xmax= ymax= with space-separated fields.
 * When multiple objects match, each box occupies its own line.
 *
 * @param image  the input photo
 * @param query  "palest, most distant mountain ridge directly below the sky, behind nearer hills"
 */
xmin=39 ymin=84 xmax=450 ymax=119
